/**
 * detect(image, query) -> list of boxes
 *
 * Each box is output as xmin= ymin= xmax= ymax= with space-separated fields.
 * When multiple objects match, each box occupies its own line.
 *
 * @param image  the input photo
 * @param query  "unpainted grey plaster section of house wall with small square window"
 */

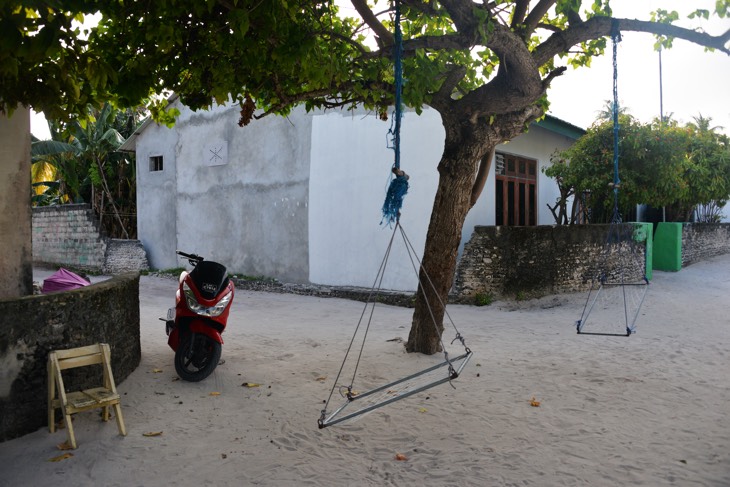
xmin=136 ymin=102 xmax=311 ymax=282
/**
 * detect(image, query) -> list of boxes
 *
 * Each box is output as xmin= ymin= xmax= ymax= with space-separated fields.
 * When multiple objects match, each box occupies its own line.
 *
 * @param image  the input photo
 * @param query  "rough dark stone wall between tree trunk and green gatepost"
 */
xmin=454 ymin=223 xmax=652 ymax=299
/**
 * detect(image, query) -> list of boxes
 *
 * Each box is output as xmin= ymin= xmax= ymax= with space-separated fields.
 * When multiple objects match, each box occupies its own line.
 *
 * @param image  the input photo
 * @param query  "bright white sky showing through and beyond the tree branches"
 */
xmin=31 ymin=0 xmax=730 ymax=139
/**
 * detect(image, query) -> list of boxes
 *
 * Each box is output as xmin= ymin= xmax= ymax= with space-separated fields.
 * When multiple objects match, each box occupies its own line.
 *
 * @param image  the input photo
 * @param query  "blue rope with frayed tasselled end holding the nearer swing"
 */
xmin=380 ymin=0 xmax=408 ymax=226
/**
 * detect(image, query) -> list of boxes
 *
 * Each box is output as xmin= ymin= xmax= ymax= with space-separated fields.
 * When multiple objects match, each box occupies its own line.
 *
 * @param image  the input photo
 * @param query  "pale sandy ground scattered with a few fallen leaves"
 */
xmin=0 ymin=255 xmax=730 ymax=486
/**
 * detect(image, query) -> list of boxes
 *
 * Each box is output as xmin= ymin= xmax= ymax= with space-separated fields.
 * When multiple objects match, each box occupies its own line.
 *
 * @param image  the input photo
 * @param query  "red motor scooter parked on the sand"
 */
xmin=164 ymin=250 xmax=234 ymax=382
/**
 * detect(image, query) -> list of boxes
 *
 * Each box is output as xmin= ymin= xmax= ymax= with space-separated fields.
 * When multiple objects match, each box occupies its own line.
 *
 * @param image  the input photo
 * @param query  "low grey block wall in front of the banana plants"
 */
xmin=33 ymin=204 xmax=149 ymax=274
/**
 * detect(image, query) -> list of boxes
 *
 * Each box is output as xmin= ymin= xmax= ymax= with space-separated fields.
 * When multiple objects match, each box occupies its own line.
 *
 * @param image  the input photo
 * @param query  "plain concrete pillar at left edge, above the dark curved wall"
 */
xmin=0 ymin=107 xmax=33 ymax=299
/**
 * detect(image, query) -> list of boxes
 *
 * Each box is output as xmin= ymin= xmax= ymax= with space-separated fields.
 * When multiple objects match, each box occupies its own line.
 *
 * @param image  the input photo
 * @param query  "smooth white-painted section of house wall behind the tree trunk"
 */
xmin=309 ymin=110 xmax=438 ymax=290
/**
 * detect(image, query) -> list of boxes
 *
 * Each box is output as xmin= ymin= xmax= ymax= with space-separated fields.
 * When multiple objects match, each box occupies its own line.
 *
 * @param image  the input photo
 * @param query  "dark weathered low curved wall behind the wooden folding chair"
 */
xmin=0 ymin=272 xmax=141 ymax=441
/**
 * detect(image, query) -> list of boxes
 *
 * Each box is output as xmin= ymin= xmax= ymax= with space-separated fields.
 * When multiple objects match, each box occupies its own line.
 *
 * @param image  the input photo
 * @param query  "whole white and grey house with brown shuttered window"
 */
xmin=122 ymin=100 xmax=583 ymax=290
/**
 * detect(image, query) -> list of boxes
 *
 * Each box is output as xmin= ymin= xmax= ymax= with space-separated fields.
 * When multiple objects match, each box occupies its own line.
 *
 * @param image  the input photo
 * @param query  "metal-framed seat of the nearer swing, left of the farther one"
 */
xmin=317 ymin=350 xmax=473 ymax=429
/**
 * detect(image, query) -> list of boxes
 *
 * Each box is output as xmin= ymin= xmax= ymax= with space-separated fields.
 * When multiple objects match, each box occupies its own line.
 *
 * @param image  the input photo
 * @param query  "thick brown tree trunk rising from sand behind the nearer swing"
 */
xmin=406 ymin=120 xmax=496 ymax=355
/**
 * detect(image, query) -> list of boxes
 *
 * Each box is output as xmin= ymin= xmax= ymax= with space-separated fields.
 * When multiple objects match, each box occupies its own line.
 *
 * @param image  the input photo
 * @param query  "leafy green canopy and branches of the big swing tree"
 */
xmin=0 ymin=0 xmax=730 ymax=124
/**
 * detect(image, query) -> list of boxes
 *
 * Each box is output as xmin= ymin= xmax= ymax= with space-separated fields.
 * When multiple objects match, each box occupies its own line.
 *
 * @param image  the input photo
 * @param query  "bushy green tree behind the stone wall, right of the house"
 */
xmin=544 ymin=114 xmax=730 ymax=223
